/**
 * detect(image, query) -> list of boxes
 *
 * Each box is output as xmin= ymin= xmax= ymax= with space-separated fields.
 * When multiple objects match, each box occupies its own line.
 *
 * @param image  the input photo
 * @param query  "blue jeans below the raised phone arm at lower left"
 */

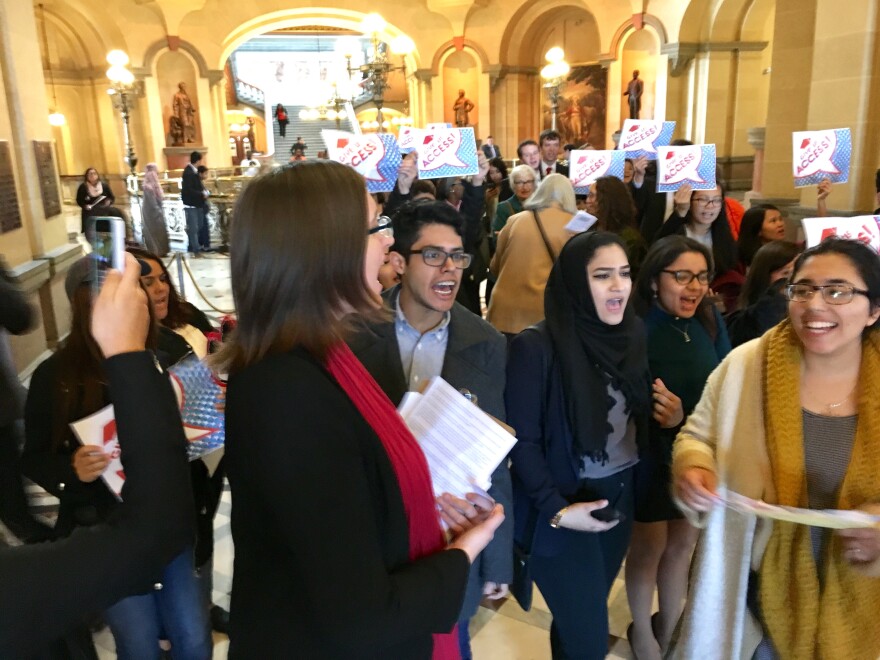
xmin=104 ymin=548 xmax=213 ymax=660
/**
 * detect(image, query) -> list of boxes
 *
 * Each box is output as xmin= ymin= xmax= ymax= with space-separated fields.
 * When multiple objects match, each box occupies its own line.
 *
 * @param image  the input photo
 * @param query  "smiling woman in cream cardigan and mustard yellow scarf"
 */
xmin=673 ymin=238 xmax=880 ymax=660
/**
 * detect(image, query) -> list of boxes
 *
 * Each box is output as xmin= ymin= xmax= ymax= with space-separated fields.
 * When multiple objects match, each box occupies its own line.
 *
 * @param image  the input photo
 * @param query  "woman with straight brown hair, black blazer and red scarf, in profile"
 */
xmin=219 ymin=161 xmax=504 ymax=659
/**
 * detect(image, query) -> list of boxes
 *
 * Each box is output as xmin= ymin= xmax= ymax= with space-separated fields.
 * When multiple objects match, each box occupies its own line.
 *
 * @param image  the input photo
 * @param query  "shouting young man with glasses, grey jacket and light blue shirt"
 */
xmin=349 ymin=202 xmax=513 ymax=659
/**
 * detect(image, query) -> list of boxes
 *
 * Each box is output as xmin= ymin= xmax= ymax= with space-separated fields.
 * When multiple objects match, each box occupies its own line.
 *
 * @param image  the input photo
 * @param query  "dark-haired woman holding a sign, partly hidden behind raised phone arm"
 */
xmin=22 ymin=257 xmax=212 ymax=660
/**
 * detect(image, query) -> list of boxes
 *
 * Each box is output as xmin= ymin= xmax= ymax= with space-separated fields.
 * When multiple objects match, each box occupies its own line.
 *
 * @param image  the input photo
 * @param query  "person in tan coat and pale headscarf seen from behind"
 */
xmin=487 ymin=174 xmax=577 ymax=335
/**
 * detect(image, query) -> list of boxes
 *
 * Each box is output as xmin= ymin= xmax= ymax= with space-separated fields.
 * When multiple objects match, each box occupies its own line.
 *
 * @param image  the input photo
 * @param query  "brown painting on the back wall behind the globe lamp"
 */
xmin=541 ymin=64 xmax=608 ymax=149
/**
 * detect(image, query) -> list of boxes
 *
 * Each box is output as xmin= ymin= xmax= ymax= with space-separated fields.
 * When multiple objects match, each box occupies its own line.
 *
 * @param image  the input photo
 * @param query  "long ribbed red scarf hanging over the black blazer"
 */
xmin=327 ymin=342 xmax=460 ymax=660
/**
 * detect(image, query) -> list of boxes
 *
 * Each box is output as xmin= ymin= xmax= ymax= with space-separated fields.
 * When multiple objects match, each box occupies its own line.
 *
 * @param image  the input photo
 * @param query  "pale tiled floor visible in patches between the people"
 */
xmin=34 ymin=214 xmax=648 ymax=660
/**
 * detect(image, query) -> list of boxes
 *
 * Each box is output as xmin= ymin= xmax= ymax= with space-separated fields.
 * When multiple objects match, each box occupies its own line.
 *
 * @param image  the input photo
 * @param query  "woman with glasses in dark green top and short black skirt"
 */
xmin=626 ymin=236 xmax=730 ymax=660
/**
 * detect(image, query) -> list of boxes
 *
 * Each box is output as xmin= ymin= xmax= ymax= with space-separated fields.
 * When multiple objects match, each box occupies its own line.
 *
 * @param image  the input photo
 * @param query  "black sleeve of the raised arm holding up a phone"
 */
xmin=0 ymin=352 xmax=193 ymax=658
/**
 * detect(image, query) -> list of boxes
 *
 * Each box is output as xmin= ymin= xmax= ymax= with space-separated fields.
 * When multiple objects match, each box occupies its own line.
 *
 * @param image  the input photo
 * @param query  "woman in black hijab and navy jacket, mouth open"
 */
xmin=505 ymin=232 xmax=651 ymax=659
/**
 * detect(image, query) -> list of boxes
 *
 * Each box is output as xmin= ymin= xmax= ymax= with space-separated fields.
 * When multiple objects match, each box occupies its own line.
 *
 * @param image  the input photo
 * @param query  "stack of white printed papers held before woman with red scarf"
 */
xmin=398 ymin=378 xmax=516 ymax=497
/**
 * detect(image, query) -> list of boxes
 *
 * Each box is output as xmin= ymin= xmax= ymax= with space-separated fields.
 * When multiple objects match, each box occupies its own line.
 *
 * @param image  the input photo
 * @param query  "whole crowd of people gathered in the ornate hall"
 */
xmin=0 ymin=122 xmax=880 ymax=660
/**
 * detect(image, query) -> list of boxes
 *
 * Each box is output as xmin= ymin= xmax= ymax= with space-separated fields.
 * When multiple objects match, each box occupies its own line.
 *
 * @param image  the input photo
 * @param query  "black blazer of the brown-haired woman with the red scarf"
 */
xmin=226 ymin=348 xmax=469 ymax=660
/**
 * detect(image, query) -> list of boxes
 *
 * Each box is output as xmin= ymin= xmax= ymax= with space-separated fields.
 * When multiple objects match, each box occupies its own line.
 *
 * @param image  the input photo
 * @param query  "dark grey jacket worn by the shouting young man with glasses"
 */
xmin=348 ymin=287 xmax=513 ymax=619
